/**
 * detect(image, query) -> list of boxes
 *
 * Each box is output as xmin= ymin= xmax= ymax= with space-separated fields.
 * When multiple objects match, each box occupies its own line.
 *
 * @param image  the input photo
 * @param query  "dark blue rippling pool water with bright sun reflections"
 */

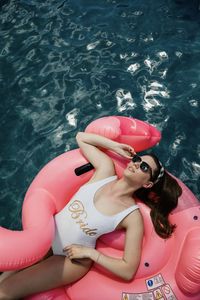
xmin=0 ymin=0 xmax=200 ymax=229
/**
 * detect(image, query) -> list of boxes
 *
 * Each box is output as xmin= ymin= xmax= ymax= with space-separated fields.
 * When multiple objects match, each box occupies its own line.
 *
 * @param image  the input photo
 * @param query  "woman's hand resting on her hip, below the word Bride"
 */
xmin=63 ymin=244 xmax=96 ymax=259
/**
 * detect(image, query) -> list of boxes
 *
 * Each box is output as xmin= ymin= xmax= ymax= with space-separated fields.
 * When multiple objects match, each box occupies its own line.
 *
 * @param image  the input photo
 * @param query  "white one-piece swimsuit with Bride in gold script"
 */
xmin=52 ymin=176 xmax=139 ymax=255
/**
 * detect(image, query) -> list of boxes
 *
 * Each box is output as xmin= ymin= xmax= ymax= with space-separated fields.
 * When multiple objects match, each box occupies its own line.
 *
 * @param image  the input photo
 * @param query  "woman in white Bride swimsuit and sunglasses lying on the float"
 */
xmin=0 ymin=132 xmax=181 ymax=299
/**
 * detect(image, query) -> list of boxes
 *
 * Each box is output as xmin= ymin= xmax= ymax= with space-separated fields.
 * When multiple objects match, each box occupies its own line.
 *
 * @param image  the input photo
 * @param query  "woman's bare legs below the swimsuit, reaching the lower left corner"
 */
xmin=0 ymin=255 xmax=92 ymax=300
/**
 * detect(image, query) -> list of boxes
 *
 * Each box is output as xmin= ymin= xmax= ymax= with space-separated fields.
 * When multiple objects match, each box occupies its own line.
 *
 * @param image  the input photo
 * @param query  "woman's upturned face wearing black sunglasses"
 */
xmin=124 ymin=155 xmax=157 ymax=187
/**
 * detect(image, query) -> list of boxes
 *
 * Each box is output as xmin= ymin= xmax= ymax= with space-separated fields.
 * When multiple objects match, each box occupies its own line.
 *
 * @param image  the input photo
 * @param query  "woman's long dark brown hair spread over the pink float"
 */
xmin=135 ymin=154 xmax=182 ymax=239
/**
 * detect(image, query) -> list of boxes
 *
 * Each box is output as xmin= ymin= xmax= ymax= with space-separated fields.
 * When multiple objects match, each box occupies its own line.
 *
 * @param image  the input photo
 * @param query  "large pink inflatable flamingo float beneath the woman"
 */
xmin=0 ymin=116 xmax=200 ymax=300
